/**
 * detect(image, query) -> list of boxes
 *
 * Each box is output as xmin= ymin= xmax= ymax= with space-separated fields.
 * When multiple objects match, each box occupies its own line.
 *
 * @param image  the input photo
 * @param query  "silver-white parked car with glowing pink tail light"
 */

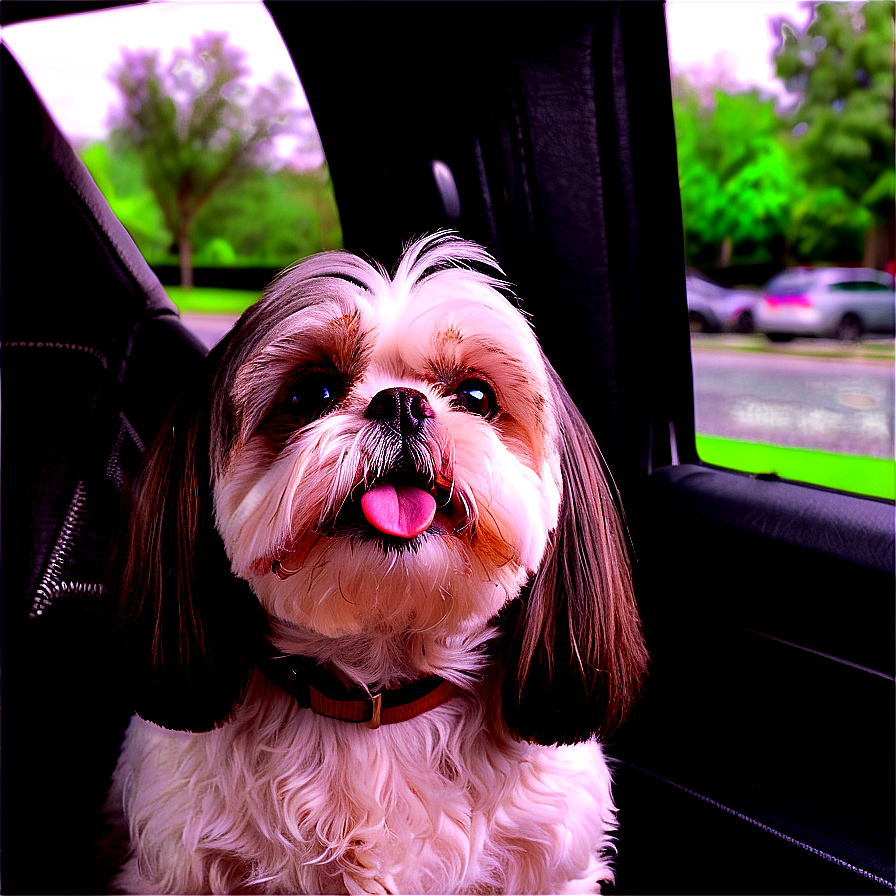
xmin=754 ymin=268 xmax=896 ymax=342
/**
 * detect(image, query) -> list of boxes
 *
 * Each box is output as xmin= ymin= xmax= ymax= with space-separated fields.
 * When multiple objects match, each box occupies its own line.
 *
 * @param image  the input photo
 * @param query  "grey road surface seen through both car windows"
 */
xmin=183 ymin=314 xmax=894 ymax=457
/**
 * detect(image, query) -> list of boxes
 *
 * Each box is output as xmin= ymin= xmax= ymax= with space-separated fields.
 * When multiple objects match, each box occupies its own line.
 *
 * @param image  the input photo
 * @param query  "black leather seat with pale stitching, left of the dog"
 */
xmin=0 ymin=48 xmax=203 ymax=893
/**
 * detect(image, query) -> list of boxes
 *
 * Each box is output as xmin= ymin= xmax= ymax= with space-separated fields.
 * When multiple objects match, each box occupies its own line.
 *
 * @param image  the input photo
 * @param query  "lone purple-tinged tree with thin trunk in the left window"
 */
xmin=109 ymin=32 xmax=299 ymax=288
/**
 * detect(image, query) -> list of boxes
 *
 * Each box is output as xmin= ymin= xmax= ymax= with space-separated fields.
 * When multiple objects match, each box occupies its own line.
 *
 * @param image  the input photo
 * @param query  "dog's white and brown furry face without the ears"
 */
xmin=214 ymin=242 xmax=562 ymax=636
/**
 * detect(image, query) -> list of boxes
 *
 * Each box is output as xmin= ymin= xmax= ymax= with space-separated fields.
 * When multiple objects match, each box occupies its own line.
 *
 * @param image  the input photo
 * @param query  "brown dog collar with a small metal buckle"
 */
xmin=257 ymin=654 xmax=464 ymax=728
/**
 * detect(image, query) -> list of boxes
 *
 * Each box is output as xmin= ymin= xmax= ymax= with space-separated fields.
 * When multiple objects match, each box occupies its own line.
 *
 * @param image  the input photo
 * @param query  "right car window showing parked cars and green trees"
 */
xmin=666 ymin=0 xmax=896 ymax=499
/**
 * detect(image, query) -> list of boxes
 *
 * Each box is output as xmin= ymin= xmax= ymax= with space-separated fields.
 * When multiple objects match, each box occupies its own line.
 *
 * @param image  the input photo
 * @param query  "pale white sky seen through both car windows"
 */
xmin=2 ymin=0 xmax=807 ymax=140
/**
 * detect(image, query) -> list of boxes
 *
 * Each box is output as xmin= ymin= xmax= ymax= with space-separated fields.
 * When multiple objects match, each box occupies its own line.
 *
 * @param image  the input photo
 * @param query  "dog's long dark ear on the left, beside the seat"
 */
xmin=109 ymin=353 xmax=265 ymax=731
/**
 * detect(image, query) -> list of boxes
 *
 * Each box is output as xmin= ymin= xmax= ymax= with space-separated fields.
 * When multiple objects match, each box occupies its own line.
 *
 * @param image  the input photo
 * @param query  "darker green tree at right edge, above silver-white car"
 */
xmin=773 ymin=0 xmax=896 ymax=266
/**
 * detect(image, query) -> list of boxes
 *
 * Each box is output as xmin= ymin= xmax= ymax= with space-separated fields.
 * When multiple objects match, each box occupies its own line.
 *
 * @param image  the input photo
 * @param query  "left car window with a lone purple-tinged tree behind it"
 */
xmin=2 ymin=0 xmax=342 ymax=343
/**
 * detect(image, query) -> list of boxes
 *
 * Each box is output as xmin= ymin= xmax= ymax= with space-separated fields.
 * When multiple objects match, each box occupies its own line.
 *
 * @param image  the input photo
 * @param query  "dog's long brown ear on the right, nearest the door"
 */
xmin=502 ymin=367 xmax=647 ymax=744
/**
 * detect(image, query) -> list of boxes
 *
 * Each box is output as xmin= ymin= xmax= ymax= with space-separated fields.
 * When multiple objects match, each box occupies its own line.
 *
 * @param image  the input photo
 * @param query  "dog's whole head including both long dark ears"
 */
xmin=119 ymin=235 xmax=646 ymax=743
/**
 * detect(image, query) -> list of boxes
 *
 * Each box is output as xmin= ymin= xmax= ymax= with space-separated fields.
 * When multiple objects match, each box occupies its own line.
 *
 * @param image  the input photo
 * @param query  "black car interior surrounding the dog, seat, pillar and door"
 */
xmin=0 ymin=0 xmax=896 ymax=894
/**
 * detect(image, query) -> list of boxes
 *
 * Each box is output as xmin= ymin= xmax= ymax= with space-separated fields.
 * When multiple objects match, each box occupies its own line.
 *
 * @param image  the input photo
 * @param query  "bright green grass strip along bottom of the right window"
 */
xmin=697 ymin=435 xmax=896 ymax=500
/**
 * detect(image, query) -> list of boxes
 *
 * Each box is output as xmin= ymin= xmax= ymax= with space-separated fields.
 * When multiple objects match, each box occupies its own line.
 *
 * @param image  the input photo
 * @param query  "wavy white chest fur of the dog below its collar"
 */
xmin=109 ymin=681 xmax=615 ymax=893
